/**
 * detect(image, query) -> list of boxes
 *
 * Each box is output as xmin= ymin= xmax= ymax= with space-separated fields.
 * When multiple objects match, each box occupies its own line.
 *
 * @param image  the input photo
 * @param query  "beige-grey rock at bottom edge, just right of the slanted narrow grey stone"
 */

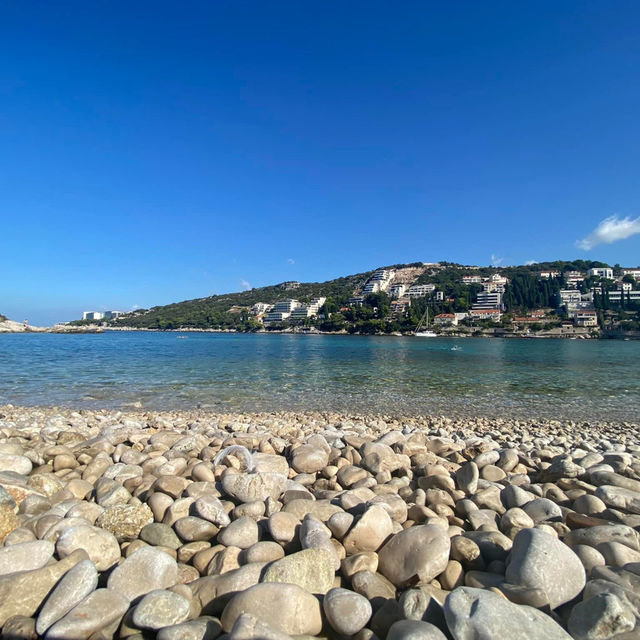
xmin=45 ymin=589 xmax=129 ymax=640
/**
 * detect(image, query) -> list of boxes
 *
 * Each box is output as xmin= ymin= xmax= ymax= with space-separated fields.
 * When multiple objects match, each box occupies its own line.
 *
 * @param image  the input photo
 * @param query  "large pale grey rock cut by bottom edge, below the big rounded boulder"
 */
xmin=444 ymin=587 xmax=571 ymax=640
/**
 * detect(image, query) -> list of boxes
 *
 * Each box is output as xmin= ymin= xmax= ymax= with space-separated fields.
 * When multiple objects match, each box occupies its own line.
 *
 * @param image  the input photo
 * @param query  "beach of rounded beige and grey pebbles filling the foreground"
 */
xmin=0 ymin=405 xmax=640 ymax=640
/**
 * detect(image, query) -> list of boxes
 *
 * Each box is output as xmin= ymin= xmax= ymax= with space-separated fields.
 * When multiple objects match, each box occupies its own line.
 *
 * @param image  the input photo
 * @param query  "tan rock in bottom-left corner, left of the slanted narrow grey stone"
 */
xmin=0 ymin=549 xmax=87 ymax=627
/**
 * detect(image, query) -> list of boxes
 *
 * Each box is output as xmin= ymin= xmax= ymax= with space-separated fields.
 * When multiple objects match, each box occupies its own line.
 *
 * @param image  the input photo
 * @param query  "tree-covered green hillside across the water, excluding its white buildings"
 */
xmin=73 ymin=260 xmax=640 ymax=333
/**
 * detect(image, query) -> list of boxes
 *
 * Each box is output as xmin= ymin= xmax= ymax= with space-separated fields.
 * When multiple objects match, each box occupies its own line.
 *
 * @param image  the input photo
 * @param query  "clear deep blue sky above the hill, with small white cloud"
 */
xmin=0 ymin=0 xmax=640 ymax=324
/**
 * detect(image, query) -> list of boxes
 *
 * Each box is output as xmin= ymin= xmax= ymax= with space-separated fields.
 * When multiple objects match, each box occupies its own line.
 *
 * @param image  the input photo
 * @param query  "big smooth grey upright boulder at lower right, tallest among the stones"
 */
xmin=505 ymin=529 xmax=586 ymax=609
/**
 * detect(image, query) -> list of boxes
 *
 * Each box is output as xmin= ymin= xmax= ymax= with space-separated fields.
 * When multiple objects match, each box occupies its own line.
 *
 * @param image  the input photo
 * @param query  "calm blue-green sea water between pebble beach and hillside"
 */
xmin=0 ymin=332 xmax=640 ymax=421
